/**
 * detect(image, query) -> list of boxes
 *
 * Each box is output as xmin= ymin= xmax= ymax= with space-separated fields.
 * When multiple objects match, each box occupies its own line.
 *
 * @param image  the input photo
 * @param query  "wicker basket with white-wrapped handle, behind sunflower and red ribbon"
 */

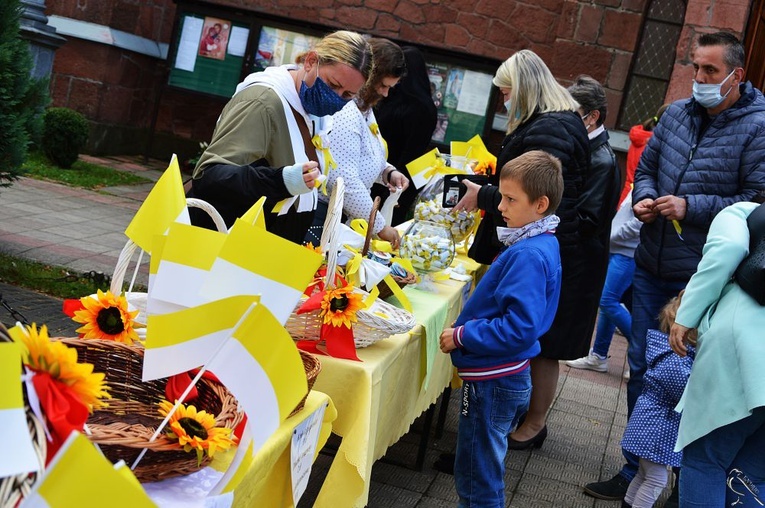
xmin=285 ymin=178 xmax=416 ymax=348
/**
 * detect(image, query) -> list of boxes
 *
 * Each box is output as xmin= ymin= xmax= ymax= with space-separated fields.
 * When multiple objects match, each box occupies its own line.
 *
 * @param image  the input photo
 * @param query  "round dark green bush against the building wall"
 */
xmin=42 ymin=108 xmax=90 ymax=168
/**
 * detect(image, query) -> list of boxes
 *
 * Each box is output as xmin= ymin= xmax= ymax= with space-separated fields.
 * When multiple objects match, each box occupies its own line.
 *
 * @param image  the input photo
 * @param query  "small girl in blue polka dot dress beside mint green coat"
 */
xmin=622 ymin=292 xmax=696 ymax=508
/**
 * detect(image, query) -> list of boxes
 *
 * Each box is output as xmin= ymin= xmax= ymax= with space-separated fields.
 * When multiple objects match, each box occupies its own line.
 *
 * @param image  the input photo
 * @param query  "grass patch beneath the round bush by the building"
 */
xmin=21 ymin=152 xmax=151 ymax=189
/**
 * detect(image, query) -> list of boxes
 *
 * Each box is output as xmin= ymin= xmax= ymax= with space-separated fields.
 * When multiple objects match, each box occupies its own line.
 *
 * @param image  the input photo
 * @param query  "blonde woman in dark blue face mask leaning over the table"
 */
xmin=190 ymin=30 xmax=372 ymax=243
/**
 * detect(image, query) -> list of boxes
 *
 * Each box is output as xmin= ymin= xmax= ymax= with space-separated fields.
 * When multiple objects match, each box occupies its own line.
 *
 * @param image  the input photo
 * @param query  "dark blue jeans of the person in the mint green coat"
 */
xmin=680 ymin=408 xmax=765 ymax=508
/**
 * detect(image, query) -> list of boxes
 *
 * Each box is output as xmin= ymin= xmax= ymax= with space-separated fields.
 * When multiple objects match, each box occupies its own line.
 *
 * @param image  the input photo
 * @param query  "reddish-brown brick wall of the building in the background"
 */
xmin=47 ymin=0 xmax=750 ymax=156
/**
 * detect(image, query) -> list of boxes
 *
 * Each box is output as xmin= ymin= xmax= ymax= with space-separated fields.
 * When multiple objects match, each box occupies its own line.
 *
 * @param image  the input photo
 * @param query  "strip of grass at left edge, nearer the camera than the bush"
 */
xmin=0 ymin=253 xmax=146 ymax=298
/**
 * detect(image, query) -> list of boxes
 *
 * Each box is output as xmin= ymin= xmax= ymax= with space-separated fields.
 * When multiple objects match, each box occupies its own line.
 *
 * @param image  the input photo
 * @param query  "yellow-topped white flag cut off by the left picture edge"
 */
xmin=0 ymin=342 xmax=40 ymax=478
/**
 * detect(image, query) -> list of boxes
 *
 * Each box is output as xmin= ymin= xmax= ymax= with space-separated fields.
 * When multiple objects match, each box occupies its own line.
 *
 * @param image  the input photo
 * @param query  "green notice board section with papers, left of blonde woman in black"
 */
xmin=428 ymin=62 xmax=492 ymax=144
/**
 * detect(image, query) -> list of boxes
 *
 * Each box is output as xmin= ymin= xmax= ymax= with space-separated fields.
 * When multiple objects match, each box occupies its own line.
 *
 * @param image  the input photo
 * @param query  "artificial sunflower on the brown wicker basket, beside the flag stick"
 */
xmin=159 ymin=400 xmax=234 ymax=464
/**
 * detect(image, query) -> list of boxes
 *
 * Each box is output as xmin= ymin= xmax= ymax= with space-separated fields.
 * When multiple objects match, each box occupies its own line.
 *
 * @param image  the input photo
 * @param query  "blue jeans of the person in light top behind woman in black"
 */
xmin=592 ymin=254 xmax=635 ymax=357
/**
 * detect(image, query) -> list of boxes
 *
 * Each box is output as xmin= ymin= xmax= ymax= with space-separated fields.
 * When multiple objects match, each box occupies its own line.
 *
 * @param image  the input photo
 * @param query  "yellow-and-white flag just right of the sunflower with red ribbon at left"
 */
xmin=143 ymin=294 xmax=260 ymax=381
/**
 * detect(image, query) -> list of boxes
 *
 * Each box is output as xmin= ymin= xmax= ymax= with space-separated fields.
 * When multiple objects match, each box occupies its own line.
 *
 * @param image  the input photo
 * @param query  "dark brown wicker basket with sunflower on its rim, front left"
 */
xmin=60 ymin=339 xmax=244 ymax=482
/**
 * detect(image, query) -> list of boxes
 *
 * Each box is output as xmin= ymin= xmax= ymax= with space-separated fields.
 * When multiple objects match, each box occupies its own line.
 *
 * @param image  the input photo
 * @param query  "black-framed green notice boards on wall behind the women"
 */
xmin=168 ymin=1 xmax=500 ymax=148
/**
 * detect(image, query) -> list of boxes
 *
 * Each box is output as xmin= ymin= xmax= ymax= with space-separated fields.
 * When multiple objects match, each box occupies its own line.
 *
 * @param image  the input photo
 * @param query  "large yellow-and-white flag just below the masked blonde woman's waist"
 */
xmin=200 ymin=219 xmax=323 ymax=324
